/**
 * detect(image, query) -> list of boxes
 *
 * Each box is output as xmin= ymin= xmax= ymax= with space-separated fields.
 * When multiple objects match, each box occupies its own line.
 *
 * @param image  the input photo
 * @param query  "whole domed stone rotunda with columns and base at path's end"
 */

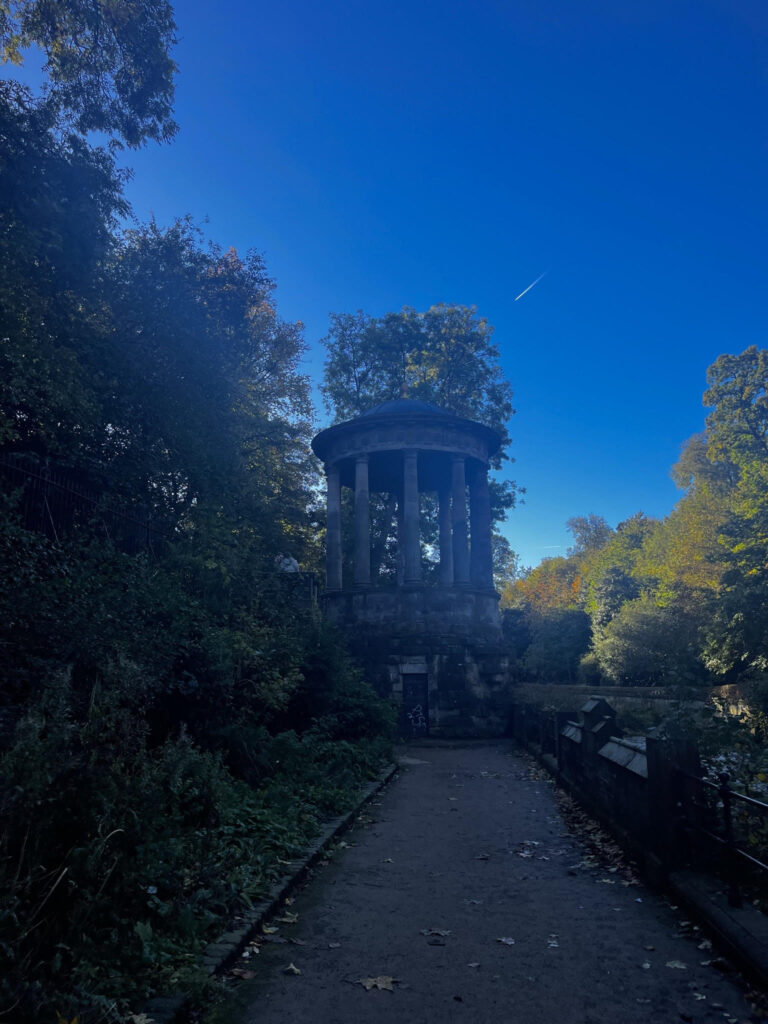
xmin=312 ymin=398 xmax=509 ymax=735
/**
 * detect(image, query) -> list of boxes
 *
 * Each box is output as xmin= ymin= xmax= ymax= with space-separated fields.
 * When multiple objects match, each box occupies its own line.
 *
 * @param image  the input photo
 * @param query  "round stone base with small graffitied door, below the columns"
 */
xmin=326 ymin=586 xmax=511 ymax=738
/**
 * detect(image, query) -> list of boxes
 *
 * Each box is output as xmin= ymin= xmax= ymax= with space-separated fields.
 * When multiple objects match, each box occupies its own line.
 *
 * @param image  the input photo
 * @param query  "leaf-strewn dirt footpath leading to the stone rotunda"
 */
xmin=219 ymin=743 xmax=759 ymax=1024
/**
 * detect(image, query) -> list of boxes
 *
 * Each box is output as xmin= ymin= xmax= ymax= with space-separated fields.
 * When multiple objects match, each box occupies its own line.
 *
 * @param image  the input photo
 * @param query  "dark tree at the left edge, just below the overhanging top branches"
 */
xmin=0 ymin=82 xmax=127 ymax=457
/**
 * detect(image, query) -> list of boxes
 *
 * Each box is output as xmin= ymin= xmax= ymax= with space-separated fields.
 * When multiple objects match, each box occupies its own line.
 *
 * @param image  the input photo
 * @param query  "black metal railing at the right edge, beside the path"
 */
xmin=678 ymin=770 xmax=768 ymax=906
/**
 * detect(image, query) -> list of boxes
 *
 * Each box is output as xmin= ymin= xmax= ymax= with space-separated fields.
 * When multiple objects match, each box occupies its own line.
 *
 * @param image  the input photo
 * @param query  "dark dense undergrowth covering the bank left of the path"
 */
xmin=0 ymin=516 xmax=391 ymax=1024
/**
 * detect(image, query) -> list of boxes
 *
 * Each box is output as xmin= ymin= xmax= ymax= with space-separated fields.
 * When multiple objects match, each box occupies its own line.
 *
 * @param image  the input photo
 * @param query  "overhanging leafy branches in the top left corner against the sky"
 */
xmin=0 ymin=0 xmax=176 ymax=146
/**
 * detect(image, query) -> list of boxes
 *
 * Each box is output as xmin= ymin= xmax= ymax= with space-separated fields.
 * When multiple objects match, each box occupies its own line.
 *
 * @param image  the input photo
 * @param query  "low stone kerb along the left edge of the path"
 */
xmin=143 ymin=764 xmax=399 ymax=1024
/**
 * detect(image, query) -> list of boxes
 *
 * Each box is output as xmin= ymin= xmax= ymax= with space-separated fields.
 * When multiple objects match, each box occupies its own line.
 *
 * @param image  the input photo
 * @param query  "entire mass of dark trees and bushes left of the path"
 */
xmin=0 ymin=24 xmax=391 ymax=1024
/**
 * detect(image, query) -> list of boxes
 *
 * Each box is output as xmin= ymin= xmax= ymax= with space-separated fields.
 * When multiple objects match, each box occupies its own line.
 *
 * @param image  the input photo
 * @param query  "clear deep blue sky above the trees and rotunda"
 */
xmin=12 ymin=0 xmax=768 ymax=564
